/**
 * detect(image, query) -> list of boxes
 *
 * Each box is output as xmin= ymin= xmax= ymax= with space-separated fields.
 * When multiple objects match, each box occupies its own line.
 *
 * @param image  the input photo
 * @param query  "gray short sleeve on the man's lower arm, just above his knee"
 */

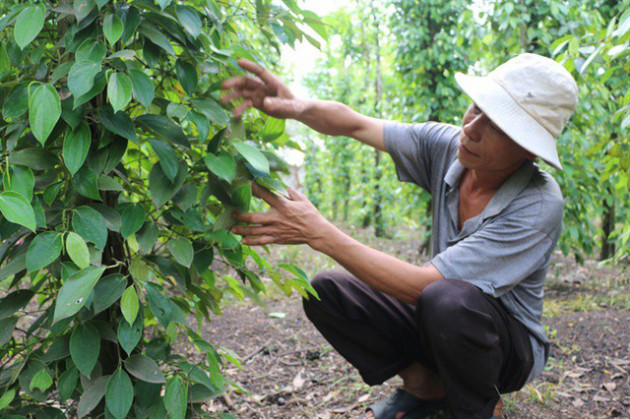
xmin=431 ymin=217 xmax=555 ymax=298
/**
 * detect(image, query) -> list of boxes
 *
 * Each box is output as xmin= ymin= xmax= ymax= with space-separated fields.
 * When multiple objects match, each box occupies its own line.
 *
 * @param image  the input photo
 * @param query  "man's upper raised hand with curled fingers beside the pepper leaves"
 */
xmin=221 ymin=58 xmax=302 ymax=118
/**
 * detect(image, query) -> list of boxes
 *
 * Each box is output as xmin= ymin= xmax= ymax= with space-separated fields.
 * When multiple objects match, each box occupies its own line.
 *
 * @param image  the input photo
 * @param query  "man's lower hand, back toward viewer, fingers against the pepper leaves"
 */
xmin=231 ymin=183 xmax=329 ymax=247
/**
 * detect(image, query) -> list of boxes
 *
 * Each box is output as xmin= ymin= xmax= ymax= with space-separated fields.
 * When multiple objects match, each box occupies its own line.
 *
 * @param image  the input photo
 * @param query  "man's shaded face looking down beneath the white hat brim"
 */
xmin=457 ymin=103 xmax=534 ymax=171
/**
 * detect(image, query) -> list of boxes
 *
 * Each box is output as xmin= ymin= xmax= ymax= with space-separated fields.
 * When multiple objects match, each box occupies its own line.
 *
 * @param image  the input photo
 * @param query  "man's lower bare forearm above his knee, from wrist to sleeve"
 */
xmin=312 ymin=223 xmax=443 ymax=304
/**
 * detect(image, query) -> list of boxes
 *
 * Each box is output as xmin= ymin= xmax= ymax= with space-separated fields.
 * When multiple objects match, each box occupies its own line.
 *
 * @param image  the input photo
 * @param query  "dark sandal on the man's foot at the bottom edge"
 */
xmin=361 ymin=388 xmax=446 ymax=419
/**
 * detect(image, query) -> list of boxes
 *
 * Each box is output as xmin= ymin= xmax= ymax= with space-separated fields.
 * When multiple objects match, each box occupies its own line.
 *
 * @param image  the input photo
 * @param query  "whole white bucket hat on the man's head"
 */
xmin=455 ymin=53 xmax=578 ymax=170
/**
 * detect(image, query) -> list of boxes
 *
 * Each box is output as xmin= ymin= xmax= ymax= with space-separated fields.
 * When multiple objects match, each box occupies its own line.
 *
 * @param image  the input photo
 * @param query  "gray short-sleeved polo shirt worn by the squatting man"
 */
xmin=384 ymin=122 xmax=563 ymax=381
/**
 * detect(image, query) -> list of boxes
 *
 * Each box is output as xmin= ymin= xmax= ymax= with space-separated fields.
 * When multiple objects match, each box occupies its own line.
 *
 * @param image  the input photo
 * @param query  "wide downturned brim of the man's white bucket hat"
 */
xmin=455 ymin=73 xmax=562 ymax=170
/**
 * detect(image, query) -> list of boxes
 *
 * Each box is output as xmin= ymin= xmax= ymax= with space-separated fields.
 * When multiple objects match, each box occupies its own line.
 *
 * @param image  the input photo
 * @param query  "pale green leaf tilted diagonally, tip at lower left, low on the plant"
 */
xmin=53 ymin=266 xmax=105 ymax=324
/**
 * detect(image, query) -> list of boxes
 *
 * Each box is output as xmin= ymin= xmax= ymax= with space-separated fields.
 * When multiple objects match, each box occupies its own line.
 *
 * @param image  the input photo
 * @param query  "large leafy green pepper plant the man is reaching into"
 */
xmin=0 ymin=0 xmax=325 ymax=419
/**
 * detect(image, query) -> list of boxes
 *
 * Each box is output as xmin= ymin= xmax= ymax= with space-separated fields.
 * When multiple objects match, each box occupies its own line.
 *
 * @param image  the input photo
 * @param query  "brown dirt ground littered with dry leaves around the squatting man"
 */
xmin=199 ymin=226 xmax=630 ymax=418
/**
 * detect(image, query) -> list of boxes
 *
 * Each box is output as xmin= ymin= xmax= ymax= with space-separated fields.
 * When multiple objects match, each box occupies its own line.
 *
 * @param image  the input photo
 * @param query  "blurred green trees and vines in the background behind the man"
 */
xmin=305 ymin=0 xmax=630 ymax=263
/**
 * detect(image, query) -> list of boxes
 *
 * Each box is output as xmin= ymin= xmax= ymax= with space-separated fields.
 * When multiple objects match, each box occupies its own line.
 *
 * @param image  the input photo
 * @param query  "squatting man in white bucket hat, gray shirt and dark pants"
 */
xmin=223 ymin=54 xmax=578 ymax=418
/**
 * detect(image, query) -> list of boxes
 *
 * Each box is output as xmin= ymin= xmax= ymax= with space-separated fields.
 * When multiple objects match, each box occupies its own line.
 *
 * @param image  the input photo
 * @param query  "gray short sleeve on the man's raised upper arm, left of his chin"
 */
xmin=383 ymin=122 xmax=460 ymax=193
